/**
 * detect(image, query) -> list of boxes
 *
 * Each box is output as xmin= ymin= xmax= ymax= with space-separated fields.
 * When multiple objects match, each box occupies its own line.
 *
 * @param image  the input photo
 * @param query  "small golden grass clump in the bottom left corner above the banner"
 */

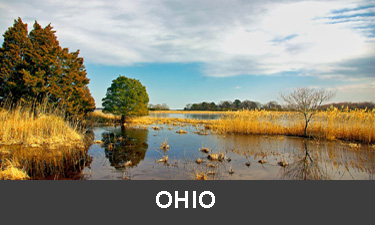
xmin=0 ymin=159 xmax=30 ymax=180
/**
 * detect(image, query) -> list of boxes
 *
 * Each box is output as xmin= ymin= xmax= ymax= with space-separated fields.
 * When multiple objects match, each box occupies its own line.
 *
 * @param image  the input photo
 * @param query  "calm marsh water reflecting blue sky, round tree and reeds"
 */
xmin=83 ymin=114 xmax=375 ymax=180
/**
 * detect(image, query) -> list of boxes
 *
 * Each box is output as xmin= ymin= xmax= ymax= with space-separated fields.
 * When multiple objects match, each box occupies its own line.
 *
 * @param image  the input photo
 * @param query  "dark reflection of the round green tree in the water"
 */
xmin=102 ymin=127 xmax=148 ymax=169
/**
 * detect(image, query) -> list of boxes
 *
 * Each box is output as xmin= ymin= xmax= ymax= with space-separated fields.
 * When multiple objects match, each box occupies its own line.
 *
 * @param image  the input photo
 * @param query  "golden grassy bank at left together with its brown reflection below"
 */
xmin=0 ymin=105 xmax=88 ymax=179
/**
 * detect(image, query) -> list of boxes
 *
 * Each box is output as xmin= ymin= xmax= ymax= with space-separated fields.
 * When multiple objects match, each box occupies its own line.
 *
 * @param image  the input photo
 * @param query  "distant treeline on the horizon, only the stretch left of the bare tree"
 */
xmin=184 ymin=99 xmax=282 ymax=111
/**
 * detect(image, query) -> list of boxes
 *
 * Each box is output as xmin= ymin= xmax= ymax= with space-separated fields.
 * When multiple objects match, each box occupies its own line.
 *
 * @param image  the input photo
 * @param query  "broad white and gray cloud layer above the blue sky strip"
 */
xmin=0 ymin=0 xmax=375 ymax=80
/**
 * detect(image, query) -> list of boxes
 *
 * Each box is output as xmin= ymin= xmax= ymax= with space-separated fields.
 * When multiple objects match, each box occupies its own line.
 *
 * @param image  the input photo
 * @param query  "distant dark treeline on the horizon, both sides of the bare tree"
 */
xmin=184 ymin=99 xmax=375 ymax=111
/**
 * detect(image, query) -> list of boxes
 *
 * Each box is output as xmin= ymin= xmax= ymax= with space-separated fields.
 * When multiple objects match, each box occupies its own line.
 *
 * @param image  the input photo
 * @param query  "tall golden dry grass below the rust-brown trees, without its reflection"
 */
xmin=0 ymin=103 xmax=84 ymax=148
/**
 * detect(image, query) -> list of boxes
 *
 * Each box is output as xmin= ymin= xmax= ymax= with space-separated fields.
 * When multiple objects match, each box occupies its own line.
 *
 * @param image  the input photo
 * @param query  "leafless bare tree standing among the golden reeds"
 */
xmin=280 ymin=87 xmax=336 ymax=136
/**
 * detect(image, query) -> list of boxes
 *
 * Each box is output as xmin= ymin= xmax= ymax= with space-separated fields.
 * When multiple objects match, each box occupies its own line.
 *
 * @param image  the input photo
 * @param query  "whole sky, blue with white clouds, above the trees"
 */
xmin=0 ymin=0 xmax=375 ymax=109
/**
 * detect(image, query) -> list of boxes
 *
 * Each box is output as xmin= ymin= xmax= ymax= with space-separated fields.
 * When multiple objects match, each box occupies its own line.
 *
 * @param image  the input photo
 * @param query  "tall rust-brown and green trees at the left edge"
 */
xmin=0 ymin=18 xmax=95 ymax=117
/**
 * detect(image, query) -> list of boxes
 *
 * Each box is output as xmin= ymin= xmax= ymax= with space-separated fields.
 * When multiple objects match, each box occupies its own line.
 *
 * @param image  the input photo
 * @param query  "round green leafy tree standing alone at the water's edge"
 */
xmin=102 ymin=75 xmax=149 ymax=124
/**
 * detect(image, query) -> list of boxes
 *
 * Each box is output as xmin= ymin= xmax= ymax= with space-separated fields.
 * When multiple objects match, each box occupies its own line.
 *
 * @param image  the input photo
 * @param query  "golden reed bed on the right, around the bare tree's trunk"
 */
xmin=209 ymin=108 xmax=375 ymax=143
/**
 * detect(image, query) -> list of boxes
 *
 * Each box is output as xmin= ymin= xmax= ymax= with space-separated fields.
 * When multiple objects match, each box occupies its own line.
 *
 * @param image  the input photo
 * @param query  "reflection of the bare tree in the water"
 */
xmin=281 ymin=141 xmax=330 ymax=180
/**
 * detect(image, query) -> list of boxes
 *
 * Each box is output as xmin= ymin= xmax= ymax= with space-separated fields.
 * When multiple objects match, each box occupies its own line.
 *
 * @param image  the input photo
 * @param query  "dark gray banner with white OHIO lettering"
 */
xmin=0 ymin=181 xmax=375 ymax=224
